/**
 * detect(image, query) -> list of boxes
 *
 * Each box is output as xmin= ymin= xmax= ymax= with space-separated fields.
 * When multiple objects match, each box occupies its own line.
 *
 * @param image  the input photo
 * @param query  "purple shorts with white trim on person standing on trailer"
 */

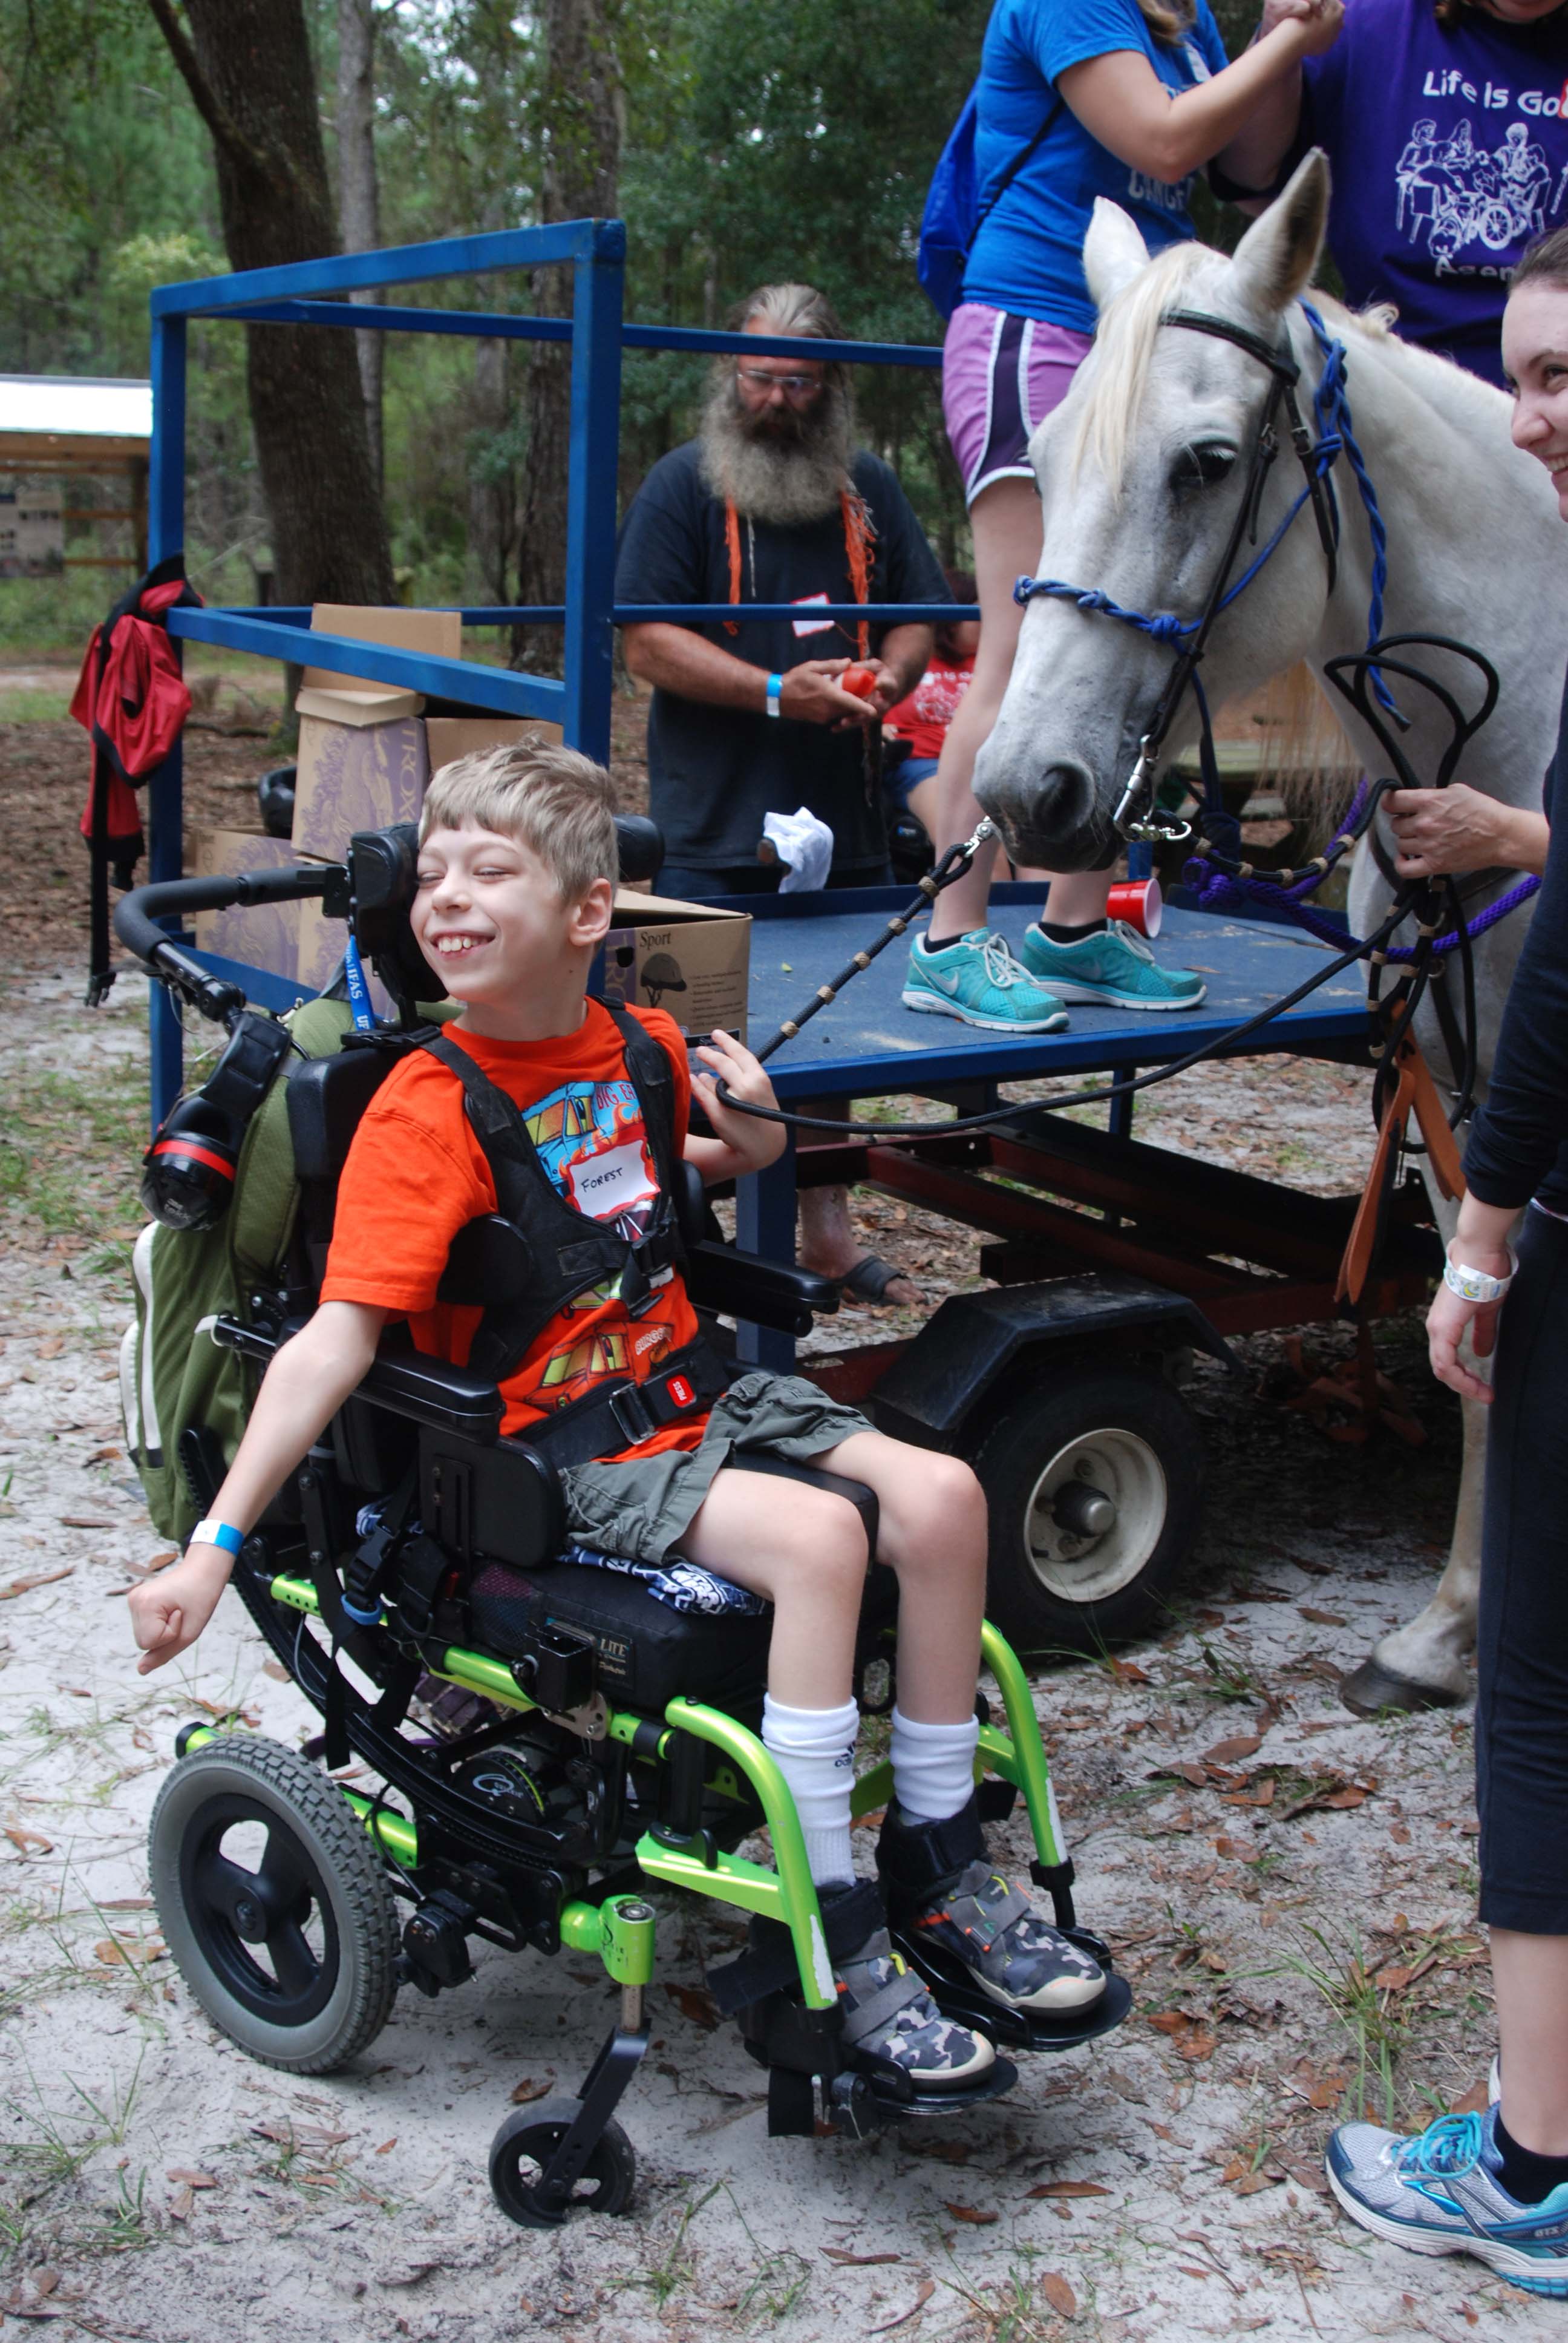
xmin=942 ymin=300 xmax=1090 ymax=503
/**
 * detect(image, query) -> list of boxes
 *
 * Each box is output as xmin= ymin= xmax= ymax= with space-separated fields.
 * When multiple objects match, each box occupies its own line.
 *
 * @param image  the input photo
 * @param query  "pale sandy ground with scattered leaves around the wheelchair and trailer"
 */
xmin=0 ymin=698 xmax=1528 ymax=2343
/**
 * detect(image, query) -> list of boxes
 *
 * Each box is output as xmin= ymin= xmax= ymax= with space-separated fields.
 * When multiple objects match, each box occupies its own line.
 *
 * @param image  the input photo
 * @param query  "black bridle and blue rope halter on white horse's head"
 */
xmin=1013 ymin=302 xmax=1404 ymax=841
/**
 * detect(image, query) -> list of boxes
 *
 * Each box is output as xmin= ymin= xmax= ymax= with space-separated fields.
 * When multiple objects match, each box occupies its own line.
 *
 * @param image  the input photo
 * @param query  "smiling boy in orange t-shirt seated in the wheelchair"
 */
xmin=131 ymin=745 xmax=1106 ymax=2092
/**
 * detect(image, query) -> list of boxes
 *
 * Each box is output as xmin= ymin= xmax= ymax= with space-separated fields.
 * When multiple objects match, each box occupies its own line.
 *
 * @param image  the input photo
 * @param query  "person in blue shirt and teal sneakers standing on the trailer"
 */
xmin=903 ymin=0 xmax=1343 ymax=1034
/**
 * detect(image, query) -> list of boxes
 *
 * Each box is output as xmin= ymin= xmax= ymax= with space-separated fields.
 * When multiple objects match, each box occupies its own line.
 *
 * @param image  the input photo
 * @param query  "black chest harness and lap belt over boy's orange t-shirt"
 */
xmin=424 ymin=1010 xmax=731 ymax=1472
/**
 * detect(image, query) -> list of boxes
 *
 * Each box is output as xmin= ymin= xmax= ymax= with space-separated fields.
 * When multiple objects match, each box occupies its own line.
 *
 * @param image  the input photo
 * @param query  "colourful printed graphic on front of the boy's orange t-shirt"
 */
xmin=523 ymin=1083 xmax=675 ymax=1408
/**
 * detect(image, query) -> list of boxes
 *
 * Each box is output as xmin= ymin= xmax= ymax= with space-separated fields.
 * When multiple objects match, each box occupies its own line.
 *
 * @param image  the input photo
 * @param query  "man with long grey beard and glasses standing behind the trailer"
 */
xmin=616 ymin=286 xmax=952 ymax=897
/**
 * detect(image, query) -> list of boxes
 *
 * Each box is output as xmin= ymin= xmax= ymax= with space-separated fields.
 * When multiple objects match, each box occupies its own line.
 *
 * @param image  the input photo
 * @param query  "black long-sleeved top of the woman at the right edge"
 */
xmin=1465 ymin=651 xmax=1568 ymax=1214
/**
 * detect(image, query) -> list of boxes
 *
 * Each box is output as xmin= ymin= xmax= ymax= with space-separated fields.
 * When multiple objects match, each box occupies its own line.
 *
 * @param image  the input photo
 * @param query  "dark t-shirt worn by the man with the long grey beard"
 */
xmin=614 ymin=441 xmax=952 ymax=871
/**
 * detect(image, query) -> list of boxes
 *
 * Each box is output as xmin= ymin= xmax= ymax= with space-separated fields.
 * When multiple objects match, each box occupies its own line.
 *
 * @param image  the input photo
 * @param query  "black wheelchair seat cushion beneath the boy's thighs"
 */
xmin=469 ymin=1563 xmax=774 ymax=1715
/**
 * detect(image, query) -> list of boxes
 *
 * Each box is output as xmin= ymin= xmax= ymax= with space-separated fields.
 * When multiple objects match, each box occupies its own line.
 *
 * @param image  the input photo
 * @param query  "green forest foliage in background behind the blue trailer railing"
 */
xmin=0 ymin=0 xmax=1256 ymax=647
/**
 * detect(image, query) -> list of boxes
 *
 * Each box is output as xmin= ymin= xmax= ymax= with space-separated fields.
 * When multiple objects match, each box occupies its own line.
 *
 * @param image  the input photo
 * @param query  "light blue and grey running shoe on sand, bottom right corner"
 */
xmin=1324 ymin=2109 xmax=1568 ymax=2301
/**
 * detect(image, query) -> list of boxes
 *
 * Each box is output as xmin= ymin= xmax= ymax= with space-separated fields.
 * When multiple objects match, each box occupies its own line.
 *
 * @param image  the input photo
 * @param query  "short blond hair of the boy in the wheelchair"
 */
xmin=420 ymin=741 xmax=619 ymax=902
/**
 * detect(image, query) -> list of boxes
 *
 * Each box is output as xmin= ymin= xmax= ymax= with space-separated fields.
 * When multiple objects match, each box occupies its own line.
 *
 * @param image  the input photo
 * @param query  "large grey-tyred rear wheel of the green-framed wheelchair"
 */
xmin=148 ymin=1734 xmax=399 ymax=2074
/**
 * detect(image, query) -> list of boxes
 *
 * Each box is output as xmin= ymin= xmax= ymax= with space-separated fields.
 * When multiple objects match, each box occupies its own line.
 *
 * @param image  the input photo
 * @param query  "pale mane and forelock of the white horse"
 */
xmin=1071 ymin=241 xmax=1507 ymax=494
